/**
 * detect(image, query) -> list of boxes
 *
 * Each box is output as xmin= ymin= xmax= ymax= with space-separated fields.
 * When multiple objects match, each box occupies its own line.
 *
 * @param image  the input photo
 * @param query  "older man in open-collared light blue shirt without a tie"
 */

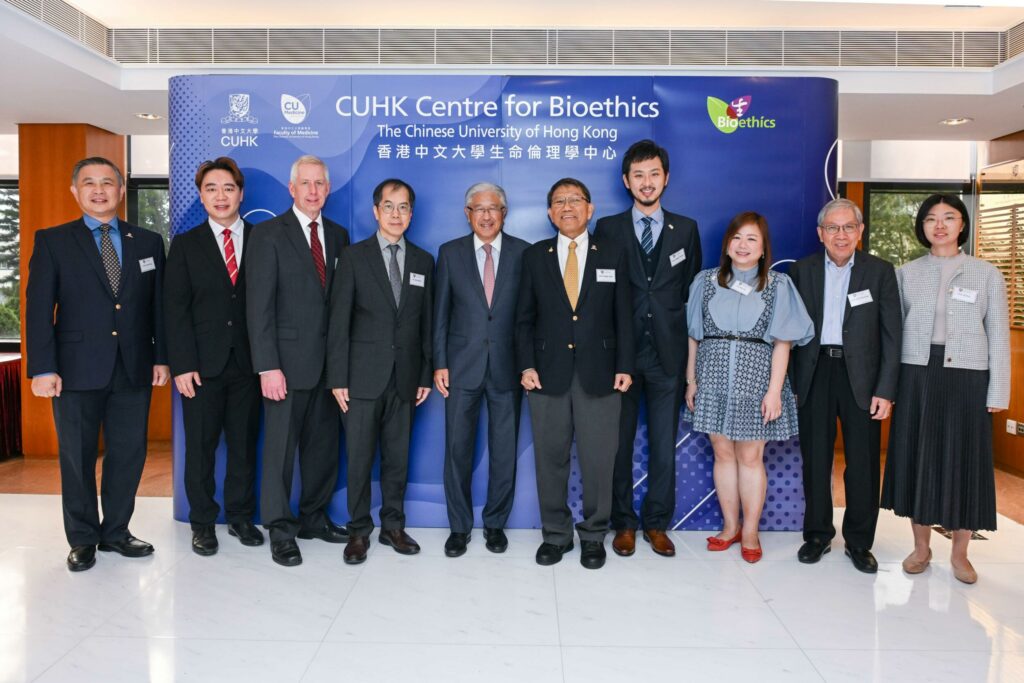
xmin=790 ymin=199 xmax=902 ymax=573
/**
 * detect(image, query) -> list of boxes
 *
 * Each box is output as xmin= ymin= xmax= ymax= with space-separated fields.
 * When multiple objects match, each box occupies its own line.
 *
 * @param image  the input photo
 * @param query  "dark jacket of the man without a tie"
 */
xmin=790 ymin=251 xmax=903 ymax=411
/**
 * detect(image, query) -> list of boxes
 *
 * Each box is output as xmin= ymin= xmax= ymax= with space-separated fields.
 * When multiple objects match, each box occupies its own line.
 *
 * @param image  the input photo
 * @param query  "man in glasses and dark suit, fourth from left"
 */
xmin=328 ymin=178 xmax=434 ymax=564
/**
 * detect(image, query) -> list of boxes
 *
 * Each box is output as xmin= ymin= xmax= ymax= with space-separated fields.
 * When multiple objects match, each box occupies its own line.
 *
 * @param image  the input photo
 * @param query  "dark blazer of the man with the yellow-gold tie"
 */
xmin=515 ymin=236 xmax=635 ymax=396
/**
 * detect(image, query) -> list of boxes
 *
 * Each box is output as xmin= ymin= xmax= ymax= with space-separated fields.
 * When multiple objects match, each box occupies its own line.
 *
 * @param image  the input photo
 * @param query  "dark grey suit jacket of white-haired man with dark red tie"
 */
xmin=245 ymin=207 xmax=348 ymax=389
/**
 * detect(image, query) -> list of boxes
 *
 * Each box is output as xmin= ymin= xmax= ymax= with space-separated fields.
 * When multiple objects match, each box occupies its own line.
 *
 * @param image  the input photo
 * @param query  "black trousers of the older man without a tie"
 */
xmin=799 ymin=354 xmax=882 ymax=549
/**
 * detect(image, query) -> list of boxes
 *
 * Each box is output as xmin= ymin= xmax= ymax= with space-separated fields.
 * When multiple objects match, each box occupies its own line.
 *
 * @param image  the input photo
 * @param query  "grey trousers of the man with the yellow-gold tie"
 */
xmin=528 ymin=374 xmax=622 ymax=546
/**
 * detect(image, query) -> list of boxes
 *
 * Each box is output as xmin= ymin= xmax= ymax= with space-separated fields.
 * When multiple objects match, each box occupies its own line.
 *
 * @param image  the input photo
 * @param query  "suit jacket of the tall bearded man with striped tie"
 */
xmin=594 ymin=207 xmax=701 ymax=377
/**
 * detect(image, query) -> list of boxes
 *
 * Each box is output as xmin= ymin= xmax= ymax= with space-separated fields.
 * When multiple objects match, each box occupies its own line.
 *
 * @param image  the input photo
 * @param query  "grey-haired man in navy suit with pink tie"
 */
xmin=433 ymin=182 xmax=529 ymax=557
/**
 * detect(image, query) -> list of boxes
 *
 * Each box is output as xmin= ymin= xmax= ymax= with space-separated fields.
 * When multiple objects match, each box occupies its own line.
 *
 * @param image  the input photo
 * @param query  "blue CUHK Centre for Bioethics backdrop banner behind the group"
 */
xmin=169 ymin=75 xmax=838 ymax=529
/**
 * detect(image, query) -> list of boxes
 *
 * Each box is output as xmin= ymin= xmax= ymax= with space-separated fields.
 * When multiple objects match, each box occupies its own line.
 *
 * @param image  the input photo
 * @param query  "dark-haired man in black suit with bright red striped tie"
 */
xmin=164 ymin=157 xmax=263 ymax=555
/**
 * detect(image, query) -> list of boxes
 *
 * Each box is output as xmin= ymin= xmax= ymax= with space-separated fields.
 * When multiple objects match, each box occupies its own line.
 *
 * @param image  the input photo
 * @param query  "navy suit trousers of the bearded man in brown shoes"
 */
xmin=611 ymin=344 xmax=683 ymax=529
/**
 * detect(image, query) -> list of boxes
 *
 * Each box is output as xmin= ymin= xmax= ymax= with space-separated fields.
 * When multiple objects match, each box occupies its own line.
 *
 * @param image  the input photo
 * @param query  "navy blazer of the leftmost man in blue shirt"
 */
xmin=25 ymin=218 xmax=167 ymax=391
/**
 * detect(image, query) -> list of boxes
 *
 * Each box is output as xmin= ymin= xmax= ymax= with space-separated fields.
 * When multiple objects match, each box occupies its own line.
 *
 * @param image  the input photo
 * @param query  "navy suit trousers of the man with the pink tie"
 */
xmin=444 ymin=373 xmax=522 ymax=533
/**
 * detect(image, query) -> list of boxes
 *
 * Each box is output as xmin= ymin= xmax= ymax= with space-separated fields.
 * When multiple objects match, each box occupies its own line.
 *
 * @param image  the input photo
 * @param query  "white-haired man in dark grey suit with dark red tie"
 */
xmin=245 ymin=156 xmax=348 ymax=566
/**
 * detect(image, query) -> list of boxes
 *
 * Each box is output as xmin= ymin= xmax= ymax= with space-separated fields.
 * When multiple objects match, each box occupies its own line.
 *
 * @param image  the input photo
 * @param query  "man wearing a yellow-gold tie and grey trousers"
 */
xmin=515 ymin=178 xmax=635 ymax=569
